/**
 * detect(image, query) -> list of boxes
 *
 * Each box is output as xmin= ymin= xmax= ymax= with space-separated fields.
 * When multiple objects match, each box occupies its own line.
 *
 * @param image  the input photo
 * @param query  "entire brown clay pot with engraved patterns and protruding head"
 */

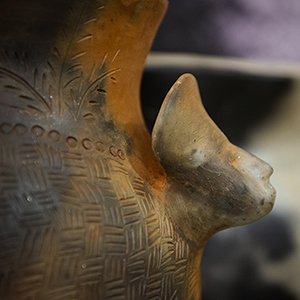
xmin=0 ymin=0 xmax=275 ymax=300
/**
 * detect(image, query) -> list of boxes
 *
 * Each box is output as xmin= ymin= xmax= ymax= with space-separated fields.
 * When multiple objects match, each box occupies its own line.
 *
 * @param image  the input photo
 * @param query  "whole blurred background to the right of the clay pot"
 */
xmin=141 ymin=0 xmax=300 ymax=300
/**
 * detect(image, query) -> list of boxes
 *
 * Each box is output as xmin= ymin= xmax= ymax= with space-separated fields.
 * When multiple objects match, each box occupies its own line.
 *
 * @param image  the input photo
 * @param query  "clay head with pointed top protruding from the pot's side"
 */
xmin=152 ymin=74 xmax=276 ymax=241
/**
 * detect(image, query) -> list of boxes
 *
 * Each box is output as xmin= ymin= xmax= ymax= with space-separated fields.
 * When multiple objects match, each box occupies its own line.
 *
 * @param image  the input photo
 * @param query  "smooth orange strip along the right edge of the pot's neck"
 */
xmin=87 ymin=0 xmax=167 ymax=188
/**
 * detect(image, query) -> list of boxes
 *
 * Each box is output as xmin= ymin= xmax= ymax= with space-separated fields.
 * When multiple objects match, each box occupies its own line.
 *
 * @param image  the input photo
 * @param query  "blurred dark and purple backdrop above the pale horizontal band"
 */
xmin=153 ymin=0 xmax=300 ymax=60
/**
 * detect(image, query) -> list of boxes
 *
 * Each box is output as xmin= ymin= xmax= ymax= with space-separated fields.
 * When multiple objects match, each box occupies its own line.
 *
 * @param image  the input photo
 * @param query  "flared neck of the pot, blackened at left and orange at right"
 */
xmin=0 ymin=0 xmax=168 ymax=186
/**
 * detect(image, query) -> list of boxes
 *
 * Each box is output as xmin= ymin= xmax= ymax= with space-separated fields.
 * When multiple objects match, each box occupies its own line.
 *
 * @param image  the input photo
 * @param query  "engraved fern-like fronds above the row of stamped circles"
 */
xmin=0 ymin=1 xmax=120 ymax=121
